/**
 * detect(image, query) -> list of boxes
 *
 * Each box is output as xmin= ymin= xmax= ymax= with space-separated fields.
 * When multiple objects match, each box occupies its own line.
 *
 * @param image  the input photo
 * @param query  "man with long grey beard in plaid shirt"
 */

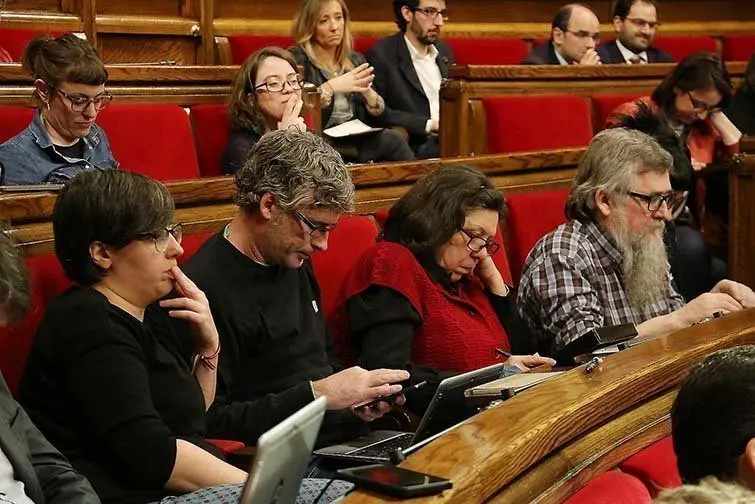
xmin=517 ymin=128 xmax=755 ymax=355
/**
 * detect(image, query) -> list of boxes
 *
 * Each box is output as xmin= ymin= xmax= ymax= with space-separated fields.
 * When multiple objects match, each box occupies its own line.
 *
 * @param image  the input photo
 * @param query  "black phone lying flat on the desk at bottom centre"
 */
xmin=338 ymin=464 xmax=453 ymax=498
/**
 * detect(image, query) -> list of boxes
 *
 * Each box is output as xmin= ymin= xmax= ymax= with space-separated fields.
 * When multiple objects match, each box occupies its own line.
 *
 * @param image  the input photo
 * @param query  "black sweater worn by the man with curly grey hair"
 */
xmin=183 ymin=234 xmax=365 ymax=446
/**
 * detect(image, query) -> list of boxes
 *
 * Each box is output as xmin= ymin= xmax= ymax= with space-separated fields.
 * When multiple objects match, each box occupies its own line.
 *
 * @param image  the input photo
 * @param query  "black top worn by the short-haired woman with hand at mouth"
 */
xmin=21 ymin=287 xmax=221 ymax=504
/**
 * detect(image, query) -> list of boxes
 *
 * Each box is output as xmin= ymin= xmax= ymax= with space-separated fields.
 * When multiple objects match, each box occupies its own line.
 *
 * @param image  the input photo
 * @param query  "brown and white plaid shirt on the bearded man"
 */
xmin=517 ymin=220 xmax=684 ymax=355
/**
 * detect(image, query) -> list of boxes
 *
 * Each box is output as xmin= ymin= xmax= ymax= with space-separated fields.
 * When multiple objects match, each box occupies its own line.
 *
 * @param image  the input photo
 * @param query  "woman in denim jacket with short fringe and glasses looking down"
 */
xmin=0 ymin=33 xmax=118 ymax=185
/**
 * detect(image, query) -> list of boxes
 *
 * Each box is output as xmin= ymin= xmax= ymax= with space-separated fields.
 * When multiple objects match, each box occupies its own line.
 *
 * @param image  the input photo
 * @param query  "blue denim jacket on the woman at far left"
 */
xmin=0 ymin=111 xmax=118 ymax=185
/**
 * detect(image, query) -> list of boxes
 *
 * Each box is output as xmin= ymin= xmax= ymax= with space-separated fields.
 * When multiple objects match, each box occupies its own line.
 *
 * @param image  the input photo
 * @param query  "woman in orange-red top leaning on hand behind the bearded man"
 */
xmin=607 ymin=52 xmax=742 ymax=260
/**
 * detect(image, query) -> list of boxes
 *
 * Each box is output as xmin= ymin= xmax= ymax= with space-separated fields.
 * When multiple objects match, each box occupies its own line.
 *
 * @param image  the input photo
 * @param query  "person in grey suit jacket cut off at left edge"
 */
xmin=0 ymin=228 xmax=100 ymax=504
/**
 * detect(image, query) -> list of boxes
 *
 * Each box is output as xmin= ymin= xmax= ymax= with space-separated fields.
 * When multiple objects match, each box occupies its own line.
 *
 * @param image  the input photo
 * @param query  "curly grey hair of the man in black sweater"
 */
xmin=234 ymin=130 xmax=354 ymax=213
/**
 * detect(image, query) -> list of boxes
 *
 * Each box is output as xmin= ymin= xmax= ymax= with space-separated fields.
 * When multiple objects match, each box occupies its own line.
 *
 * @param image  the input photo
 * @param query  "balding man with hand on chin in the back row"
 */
xmin=522 ymin=4 xmax=601 ymax=65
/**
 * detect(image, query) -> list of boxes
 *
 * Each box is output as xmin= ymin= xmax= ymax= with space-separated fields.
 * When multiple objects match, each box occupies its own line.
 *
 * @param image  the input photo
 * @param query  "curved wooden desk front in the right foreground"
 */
xmin=346 ymin=309 xmax=755 ymax=504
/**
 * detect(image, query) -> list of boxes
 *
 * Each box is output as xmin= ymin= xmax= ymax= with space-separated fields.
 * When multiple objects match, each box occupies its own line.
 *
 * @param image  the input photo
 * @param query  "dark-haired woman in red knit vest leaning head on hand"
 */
xmin=336 ymin=166 xmax=554 ymax=415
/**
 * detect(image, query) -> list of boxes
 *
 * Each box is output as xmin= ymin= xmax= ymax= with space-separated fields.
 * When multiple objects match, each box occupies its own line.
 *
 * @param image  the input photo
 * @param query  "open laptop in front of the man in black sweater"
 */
xmin=315 ymin=363 xmax=503 ymax=463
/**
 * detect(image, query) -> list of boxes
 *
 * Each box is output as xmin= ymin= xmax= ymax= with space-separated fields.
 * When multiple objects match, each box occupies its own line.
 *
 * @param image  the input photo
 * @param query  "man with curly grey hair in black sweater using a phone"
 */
xmin=184 ymin=130 xmax=409 ymax=445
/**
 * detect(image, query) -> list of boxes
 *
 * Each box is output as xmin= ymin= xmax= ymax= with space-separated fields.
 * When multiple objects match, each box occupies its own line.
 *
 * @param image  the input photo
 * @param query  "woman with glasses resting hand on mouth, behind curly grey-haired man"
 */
xmin=221 ymin=46 xmax=307 ymax=175
